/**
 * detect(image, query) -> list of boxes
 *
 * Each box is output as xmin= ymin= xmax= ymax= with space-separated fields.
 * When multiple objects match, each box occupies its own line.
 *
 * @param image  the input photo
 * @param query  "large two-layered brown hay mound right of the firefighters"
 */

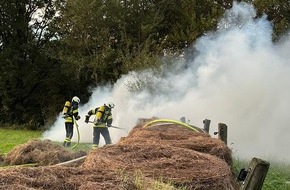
xmin=82 ymin=121 xmax=237 ymax=190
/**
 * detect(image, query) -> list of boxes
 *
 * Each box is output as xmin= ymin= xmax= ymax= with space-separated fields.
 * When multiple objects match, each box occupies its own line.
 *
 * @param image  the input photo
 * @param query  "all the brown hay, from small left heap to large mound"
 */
xmin=0 ymin=120 xmax=238 ymax=190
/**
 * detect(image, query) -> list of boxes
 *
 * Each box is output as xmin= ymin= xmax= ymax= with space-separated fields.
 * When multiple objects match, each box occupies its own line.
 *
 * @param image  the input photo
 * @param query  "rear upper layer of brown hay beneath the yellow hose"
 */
xmin=119 ymin=124 xmax=232 ymax=165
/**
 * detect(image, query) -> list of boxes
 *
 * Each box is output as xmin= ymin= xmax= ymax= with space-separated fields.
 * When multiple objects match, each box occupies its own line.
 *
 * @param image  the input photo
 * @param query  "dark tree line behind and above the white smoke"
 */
xmin=0 ymin=0 xmax=290 ymax=129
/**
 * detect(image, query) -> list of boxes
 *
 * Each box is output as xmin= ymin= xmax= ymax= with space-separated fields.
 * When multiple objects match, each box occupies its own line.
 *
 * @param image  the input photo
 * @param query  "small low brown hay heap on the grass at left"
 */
xmin=4 ymin=139 xmax=86 ymax=166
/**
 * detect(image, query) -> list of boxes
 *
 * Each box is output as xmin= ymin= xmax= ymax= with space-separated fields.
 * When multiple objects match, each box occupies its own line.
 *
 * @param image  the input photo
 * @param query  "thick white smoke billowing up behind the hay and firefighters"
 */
xmin=44 ymin=2 xmax=290 ymax=161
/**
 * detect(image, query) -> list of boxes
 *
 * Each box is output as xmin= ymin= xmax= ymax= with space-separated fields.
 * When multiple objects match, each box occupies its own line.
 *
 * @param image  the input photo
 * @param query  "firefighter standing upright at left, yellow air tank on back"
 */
xmin=62 ymin=96 xmax=81 ymax=147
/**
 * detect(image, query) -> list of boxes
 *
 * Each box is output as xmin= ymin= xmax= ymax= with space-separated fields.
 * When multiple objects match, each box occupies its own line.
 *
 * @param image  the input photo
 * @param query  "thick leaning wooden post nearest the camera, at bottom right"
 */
xmin=240 ymin=158 xmax=270 ymax=190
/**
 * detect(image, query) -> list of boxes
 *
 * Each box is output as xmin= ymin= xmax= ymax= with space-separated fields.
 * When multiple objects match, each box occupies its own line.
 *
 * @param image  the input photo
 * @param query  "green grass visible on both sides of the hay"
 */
xmin=0 ymin=128 xmax=290 ymax=190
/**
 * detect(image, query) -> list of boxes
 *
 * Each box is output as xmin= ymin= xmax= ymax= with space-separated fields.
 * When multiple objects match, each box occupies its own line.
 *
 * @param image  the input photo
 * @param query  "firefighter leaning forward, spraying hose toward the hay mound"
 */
xmin=85 ymin=102 xmax=115 ymax=149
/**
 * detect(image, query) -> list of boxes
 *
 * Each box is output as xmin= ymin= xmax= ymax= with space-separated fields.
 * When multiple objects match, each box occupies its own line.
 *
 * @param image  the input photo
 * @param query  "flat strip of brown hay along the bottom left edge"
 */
xmin=0 ymin=166 xmax=142 ymax=190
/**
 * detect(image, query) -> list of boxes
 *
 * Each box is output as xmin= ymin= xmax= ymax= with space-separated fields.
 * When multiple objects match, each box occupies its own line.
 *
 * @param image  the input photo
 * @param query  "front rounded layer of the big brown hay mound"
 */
xmin=82 ymin=143 xmax=235 ymax=189
